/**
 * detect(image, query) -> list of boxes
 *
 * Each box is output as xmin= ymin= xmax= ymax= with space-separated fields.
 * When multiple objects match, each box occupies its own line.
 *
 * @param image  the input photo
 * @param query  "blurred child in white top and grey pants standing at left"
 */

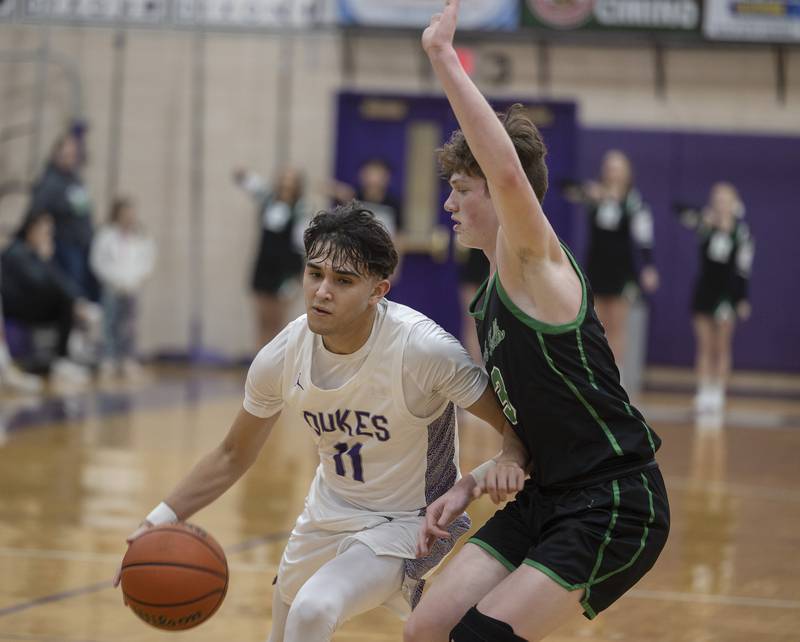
xmin=90 ymin=198 xmax=156 ymax=378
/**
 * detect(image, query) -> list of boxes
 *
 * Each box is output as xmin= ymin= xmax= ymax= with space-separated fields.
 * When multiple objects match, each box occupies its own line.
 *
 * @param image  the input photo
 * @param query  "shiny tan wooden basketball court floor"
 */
xmin=0 ymin=369 xmax=800 ymax=642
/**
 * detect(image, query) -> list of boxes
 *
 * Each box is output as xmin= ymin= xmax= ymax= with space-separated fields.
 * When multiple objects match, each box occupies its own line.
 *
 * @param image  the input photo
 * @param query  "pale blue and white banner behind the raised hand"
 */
xmin=338 ymin=0 xmax=519 ymax=30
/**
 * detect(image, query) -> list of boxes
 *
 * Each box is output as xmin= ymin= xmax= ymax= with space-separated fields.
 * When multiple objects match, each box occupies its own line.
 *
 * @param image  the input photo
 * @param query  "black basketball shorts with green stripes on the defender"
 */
xmin=469 ymin=466 xmax=669 ymax=619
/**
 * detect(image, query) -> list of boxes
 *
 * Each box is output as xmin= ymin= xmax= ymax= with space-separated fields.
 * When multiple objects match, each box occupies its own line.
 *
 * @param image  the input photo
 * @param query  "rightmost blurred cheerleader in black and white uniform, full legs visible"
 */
xmin=676 ymin=183 xmax=754 ymax=413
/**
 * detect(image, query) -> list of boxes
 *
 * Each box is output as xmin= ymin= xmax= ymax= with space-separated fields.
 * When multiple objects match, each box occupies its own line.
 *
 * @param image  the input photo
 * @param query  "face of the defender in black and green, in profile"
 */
xmin=444 ymin=172 xmax=499 ymax=250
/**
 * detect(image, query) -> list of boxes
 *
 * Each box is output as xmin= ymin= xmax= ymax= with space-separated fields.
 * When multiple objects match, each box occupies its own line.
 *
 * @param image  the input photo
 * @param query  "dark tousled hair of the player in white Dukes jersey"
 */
xmin=303 ymin=201 xmax=397 ymax=279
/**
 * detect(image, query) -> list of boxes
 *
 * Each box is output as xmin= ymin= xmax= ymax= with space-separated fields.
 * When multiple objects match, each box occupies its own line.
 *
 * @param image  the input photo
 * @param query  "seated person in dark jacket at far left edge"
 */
xmin=0 ymin=212 xmax=96 ymax=384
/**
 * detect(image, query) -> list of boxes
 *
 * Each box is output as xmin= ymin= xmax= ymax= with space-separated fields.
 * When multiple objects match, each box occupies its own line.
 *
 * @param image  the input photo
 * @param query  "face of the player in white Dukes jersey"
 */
xmin=303 ymin=258 xmax=389 ymax=336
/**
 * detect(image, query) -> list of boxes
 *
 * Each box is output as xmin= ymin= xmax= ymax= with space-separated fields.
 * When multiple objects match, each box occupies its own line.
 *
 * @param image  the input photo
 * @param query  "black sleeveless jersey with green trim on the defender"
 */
xmin=470 ymin=247 xmax=661 ymax=486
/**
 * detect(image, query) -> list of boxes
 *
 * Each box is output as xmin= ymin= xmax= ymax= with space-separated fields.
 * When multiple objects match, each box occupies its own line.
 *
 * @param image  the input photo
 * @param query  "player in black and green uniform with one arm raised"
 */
xmin=404 ymin=5 xmax=669 ymax=642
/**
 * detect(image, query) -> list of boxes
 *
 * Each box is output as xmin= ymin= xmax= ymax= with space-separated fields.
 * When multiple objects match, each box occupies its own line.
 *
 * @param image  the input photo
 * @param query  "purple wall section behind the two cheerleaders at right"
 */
xmin=573 ymin=128 xmax=800 ymax=372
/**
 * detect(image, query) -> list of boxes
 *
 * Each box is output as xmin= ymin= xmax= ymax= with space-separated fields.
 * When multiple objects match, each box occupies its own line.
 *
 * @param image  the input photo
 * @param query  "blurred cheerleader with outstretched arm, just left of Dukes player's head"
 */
xmin=233 ymin=168 xmax=308 ymax=347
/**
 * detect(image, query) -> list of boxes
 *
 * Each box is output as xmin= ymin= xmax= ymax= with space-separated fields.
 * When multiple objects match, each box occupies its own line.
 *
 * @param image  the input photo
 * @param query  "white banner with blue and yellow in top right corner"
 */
xmin=703 ymin=0 xmax=800 ymax=42
